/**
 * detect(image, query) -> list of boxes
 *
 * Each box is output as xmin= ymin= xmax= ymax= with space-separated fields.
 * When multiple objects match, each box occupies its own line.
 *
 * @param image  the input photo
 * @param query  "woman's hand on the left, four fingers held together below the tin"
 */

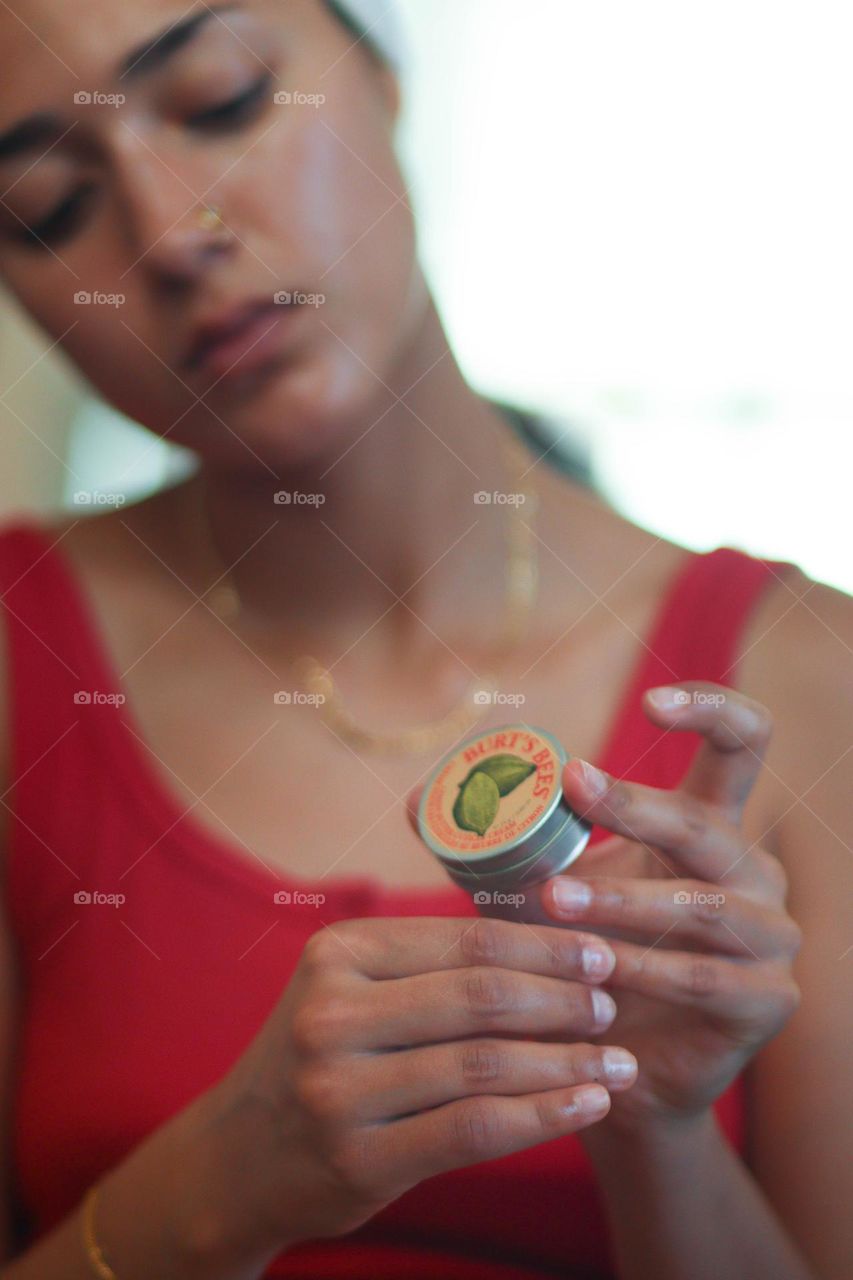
xmin=204 ymin=916 xmax=637 ymax=1248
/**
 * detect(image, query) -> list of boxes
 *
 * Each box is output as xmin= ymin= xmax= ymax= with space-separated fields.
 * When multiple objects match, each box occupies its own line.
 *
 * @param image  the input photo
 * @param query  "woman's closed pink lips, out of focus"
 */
xmin=183 ymin=296 xmax=302 ymax=381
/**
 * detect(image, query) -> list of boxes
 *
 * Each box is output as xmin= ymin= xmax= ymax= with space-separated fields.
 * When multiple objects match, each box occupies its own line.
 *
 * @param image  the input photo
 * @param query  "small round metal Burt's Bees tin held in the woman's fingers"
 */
xmin=418 ymin=724 xmax=592 ymax=918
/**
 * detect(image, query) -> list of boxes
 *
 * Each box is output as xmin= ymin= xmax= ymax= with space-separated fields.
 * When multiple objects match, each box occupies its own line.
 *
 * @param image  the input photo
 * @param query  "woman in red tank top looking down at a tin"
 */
xmin=0 ymin=0 xmax=853 ymax=1280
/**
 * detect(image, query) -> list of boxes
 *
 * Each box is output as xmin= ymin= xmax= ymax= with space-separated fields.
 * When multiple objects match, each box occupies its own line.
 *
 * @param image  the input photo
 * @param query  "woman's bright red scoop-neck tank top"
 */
xmin=0 ymin=518 xmax=786 ymax=1280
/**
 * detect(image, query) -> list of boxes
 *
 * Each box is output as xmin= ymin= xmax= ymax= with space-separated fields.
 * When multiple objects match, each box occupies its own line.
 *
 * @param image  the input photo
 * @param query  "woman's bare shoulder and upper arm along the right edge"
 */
xmin=722 ymin=570 xmax=853 ymax=1277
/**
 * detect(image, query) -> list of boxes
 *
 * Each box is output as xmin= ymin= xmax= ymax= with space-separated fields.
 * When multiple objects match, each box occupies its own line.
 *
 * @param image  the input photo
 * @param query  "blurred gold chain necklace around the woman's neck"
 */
xmin=200 ymin=419 xmax=539 ymax=755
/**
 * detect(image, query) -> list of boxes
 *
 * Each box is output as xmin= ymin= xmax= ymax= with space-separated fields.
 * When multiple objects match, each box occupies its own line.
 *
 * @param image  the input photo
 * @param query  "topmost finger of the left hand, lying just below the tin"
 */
xmin=310 ymin=915 xmax=616 ymax=982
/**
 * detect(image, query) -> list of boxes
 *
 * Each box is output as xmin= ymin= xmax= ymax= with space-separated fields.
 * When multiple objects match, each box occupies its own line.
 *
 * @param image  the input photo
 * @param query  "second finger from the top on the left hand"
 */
xmin=343 ymin=966 xmax=616 ymax=1051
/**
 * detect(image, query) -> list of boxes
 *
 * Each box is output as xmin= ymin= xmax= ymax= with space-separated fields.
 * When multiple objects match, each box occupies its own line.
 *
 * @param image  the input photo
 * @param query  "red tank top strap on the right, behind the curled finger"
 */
xmin=601 ymin=547 xmax=795 ymax=787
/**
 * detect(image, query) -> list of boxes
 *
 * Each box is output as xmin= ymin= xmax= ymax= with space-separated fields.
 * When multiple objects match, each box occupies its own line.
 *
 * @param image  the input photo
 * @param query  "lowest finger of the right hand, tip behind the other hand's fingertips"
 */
xmin=607 ymin=942 xmax=798 ymax=1033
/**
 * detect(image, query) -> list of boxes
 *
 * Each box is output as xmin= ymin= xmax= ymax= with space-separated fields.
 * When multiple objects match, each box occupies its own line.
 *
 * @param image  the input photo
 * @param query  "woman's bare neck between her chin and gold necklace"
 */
xmin=181 ymin=300 xmax=533 ymax=664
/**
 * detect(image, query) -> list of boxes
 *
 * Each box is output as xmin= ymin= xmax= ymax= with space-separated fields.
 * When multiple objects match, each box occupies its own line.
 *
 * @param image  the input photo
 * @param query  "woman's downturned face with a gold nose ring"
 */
xmin=0 ymin=0 xmax=427 ymax=468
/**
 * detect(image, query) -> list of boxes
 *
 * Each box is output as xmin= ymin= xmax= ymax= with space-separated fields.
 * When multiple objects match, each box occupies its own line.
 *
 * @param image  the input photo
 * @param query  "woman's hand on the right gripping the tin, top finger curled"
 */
xmin=540 ymin=681 xmax=802 ymax=1132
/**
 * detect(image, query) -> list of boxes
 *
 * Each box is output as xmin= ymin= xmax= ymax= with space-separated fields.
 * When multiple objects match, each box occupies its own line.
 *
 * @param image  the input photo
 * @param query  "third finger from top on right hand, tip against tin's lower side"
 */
xmin=542 ymin=876 xmax=799 ymax=959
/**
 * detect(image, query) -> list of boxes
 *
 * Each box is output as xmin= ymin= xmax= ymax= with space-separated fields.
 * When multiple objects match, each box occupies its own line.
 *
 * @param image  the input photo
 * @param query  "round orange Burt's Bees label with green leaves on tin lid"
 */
xmin=423 ymin=728 xmax=562 ymax=858
